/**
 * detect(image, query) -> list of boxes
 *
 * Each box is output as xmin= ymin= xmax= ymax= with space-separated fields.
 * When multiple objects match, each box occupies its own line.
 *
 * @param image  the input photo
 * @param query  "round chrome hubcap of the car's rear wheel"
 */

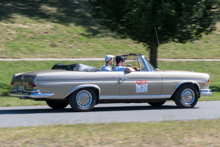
xmin=76 ymin=90 xmax=92 ymax=107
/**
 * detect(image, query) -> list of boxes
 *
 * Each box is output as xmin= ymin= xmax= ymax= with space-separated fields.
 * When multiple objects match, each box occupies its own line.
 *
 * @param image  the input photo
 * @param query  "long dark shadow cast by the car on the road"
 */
xmin=0 ymin=105 xmax=197 ymax=115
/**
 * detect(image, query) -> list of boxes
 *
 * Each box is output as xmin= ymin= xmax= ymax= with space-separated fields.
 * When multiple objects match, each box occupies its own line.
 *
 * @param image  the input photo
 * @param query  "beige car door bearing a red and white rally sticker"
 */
xmin=119 ymin=71 xmax=162 ymax=96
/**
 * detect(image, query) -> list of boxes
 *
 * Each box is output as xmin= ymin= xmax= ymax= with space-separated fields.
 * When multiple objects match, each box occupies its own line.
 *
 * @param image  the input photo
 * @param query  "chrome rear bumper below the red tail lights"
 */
xmin=9 ymin=89 xmax=54 ymax=99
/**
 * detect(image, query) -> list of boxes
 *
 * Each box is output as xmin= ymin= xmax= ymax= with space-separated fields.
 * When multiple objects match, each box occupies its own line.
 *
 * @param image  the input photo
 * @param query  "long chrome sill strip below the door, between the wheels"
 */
xmin=99 ymin=95 xmax=171 ymax=100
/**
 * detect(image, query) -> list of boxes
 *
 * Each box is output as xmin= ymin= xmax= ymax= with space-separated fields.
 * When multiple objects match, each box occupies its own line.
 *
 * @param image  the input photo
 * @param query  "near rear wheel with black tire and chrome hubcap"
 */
xmin=69 ymin=88 xmax=97 ymax=112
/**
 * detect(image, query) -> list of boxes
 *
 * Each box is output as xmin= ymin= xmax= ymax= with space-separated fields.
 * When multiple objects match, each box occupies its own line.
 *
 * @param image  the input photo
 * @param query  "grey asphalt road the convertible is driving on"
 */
xmin=0 ymin=101 xmax=220 ymax=127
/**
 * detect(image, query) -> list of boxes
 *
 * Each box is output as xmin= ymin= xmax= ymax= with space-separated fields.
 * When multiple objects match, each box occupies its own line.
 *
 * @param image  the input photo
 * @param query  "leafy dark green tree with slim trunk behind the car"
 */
xmin=89 ymin=0 xmax=219 ymax=67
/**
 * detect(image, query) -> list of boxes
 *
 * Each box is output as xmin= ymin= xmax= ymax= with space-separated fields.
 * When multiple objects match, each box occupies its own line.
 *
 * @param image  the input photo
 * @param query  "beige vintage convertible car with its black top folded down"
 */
xmin=10 ymin=54 xmax=212 ymax=111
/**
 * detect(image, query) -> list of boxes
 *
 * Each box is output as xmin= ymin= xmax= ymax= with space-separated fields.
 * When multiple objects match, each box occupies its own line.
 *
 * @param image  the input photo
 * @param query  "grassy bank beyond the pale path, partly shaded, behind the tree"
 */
xmin=0 ymin=0 xmax=220 ymax=58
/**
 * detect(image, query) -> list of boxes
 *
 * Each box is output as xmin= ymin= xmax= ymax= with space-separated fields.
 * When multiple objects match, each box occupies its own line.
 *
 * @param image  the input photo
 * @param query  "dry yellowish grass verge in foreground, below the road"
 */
xmin=0 ymin=119 xmax=220 ymax=147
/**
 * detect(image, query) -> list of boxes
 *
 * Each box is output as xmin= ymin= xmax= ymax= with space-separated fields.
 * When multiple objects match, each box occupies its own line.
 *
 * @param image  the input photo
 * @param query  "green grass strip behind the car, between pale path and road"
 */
xmin=0 ymin=61 xmax=220 ymax=106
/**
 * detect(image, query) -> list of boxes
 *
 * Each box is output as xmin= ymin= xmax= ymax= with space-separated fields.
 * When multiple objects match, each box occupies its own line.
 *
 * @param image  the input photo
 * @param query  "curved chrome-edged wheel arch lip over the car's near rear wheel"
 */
xmin=64 ymin=84 xmax=101 ymax=101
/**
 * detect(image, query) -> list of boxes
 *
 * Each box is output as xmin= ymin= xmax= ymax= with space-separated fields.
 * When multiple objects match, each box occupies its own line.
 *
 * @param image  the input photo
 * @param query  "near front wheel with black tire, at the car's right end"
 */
xmin=174 ymin=84 xmax=199 ymax=108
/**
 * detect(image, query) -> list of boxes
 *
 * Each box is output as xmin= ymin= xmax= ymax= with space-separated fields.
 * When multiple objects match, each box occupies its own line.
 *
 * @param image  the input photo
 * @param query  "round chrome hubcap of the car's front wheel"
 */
xmin=181 ymin=88 xmax=195 ymax=105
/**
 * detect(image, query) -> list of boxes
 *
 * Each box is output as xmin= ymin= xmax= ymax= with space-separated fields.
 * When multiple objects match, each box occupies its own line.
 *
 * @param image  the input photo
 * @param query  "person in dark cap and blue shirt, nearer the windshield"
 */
xmin=113 ymin=56 xmax=135 ymax=73
